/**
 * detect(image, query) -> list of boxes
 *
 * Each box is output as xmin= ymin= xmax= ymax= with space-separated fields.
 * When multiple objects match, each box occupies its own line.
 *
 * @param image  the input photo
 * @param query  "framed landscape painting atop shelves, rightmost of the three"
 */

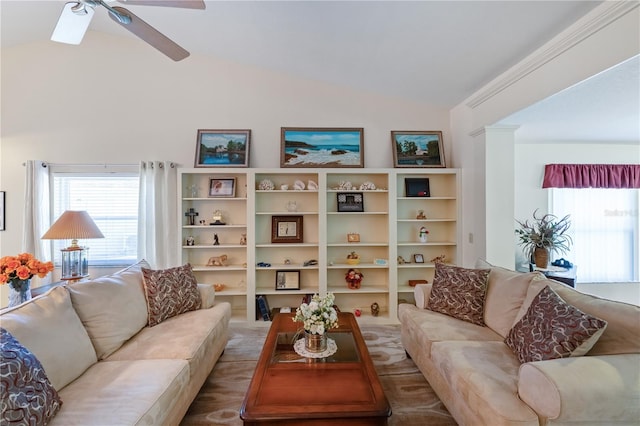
xmin=391 ymin=130 xmax=446 ymax=167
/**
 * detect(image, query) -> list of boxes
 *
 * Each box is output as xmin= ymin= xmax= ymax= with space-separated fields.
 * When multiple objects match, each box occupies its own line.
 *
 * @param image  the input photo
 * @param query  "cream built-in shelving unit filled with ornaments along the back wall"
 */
xmin=178 ymin=168 xmax=461 ymax=323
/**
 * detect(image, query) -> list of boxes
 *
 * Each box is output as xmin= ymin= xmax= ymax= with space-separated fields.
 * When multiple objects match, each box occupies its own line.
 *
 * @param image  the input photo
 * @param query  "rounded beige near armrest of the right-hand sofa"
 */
xmin=518 ymin=354 xmax=640 ymax=424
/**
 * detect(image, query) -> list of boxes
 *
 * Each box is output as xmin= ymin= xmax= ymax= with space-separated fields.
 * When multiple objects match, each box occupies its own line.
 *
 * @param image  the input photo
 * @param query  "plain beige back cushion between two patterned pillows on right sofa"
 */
xmin=484 ymin=266 xmax=541 ymax=337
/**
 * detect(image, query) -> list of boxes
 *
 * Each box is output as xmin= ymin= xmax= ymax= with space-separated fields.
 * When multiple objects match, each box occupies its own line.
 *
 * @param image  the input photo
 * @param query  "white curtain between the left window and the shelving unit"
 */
xmin=138 ymin=161 xmax=179 ymax=269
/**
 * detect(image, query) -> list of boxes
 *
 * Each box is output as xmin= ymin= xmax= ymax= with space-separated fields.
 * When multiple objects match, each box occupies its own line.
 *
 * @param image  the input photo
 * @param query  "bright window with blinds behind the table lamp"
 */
xmin=51 ymin=166 xmax=139 ymax=267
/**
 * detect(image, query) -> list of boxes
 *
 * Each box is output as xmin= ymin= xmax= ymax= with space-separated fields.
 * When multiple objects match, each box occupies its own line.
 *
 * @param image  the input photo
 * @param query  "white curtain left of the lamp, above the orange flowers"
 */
xmin=22 ymin=160 xmax=53 ymax=284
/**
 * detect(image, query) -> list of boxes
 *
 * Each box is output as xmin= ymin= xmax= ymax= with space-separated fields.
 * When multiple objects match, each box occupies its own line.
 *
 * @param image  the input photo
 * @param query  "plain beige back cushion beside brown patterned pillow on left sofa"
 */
xmin=69 ymin=260 xmax=149 ymax=359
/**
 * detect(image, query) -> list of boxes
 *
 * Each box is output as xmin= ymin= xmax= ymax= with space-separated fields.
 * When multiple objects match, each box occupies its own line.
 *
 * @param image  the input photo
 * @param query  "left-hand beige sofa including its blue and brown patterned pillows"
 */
xmin=0 ymin=261 xmax=231 ymax=426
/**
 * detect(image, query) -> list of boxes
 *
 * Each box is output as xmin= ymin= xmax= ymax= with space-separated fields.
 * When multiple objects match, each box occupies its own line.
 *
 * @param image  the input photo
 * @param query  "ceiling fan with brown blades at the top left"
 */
xmin=51 ymin=0 xmax=205 ymax=61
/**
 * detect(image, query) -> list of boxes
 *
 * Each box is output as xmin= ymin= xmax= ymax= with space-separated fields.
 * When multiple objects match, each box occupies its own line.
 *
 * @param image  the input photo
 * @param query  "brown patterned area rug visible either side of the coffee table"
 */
xmin=181 ymin=324 xmax=456 ymax=426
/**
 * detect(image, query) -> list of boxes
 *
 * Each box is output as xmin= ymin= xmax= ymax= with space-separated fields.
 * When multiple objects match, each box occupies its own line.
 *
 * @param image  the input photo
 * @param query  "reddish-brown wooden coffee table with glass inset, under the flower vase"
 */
xmin=240 ymin=313 xmax=391 ymax=425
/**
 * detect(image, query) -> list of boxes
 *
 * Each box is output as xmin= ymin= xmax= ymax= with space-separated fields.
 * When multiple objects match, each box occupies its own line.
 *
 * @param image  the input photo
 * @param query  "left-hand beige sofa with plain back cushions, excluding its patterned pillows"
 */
xmin=0 ymin=261 xmax=231 ymax=426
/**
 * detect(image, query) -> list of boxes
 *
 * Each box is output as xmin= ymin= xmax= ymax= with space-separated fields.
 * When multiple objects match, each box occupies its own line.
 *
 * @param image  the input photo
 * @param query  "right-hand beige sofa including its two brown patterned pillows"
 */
xmin=399 ymin=264 xmax=640 ymax=426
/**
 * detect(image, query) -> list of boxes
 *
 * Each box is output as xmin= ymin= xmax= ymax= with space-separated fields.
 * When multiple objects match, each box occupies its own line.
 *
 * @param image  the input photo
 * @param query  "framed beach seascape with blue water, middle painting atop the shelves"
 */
xmin=280 ymin=127 xmax=364 ymax=168
